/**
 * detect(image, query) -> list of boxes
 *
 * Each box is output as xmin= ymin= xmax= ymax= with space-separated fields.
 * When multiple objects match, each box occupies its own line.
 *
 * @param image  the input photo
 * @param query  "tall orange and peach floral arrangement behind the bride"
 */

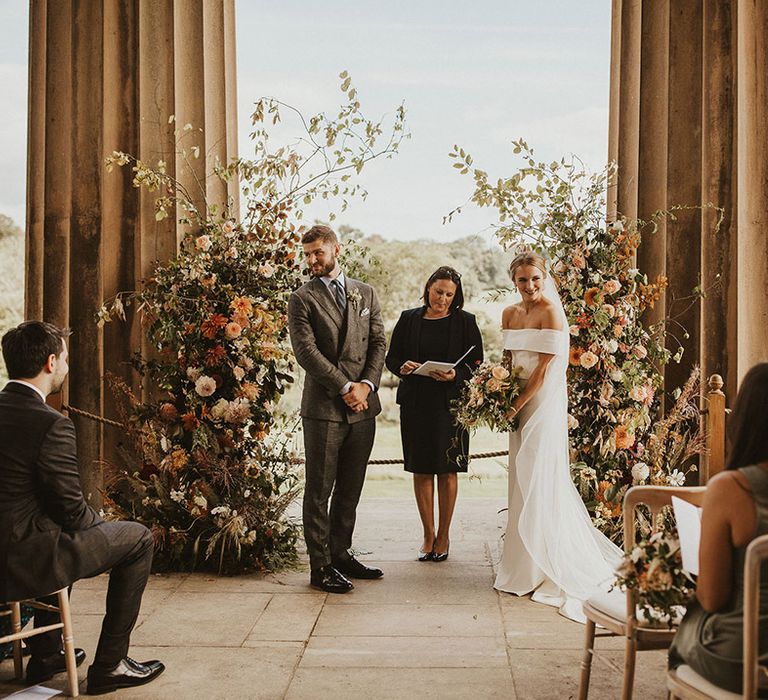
xmin=449 ymin=140 xmax=702 ymax=542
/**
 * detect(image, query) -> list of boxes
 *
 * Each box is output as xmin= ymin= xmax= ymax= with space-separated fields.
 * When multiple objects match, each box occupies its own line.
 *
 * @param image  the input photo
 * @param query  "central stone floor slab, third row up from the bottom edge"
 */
xmin=313 ymin=604 xmax=502 ymax=638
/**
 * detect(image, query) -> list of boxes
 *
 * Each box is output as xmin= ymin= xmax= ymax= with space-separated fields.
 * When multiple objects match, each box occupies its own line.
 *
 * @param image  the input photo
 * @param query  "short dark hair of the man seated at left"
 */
xmin=1 ymin=321 xmax=72 ymax=379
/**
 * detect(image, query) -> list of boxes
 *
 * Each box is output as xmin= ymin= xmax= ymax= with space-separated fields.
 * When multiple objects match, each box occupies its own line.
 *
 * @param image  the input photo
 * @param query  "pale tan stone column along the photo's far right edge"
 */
xmin=731 ymin=0 xmax=768 ymax=380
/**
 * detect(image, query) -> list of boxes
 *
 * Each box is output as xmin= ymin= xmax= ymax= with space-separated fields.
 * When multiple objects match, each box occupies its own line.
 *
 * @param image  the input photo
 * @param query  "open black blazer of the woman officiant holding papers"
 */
xmin=385 ymin=306 xmax=483 ymax=408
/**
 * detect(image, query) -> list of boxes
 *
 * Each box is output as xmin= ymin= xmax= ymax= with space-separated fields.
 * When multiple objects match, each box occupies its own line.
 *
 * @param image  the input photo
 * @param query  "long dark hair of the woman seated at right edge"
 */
xmin=726 ymin=362 xmax=768 ymax=469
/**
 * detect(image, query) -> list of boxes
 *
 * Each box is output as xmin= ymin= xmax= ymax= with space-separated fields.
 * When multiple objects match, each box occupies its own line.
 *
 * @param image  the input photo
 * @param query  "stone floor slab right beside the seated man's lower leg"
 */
xmin=131 ymin=587 xmax=271 ymax=647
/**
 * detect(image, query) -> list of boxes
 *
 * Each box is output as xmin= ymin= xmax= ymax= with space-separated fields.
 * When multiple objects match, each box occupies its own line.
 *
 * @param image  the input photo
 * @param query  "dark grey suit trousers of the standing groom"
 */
xmin=302 ymin=418 xmax=376 ymax=569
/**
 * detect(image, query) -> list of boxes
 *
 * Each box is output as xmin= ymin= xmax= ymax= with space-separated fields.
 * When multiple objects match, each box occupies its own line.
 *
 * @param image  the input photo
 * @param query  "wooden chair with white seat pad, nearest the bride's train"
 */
xmin=578 ymin=486 xmax=706 ymax=700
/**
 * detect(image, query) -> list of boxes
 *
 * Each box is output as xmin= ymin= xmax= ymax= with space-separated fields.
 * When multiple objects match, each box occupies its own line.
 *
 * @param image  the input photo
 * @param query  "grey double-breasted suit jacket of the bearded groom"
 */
xmin=288 ymin=277 xmax=387 ymax=423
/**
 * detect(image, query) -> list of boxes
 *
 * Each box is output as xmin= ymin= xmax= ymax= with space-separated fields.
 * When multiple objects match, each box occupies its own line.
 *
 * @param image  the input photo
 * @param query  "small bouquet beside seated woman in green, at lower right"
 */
xmin=615 ymin=530 xmax=696 ymax=627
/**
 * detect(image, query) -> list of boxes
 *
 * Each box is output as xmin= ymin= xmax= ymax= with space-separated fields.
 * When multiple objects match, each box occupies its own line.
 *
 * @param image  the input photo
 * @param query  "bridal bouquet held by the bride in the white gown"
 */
xmin=452 ymin=362 xmax=520 ymax=432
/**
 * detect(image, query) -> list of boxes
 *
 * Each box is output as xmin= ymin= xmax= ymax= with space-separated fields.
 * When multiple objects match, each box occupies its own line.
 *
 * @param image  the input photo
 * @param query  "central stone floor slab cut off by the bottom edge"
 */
xmin=286 ymin=668 xmax=515 ymax=700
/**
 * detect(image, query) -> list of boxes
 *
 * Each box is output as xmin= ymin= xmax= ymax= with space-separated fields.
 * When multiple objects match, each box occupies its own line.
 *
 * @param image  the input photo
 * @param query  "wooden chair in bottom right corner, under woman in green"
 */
xmin=667 ymin=535 xmax=768 ymax=700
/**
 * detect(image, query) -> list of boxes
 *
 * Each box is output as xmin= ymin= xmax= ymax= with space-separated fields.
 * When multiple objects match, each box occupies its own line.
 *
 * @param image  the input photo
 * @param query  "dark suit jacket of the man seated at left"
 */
xmin=0 ymin=382 xmax=104 ymax=601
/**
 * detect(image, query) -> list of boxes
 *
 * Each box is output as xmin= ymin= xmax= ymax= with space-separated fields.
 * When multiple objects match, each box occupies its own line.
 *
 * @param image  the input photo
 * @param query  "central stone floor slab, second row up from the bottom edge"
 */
xmin=299 ymin=636 xmax=507 ymax=669
